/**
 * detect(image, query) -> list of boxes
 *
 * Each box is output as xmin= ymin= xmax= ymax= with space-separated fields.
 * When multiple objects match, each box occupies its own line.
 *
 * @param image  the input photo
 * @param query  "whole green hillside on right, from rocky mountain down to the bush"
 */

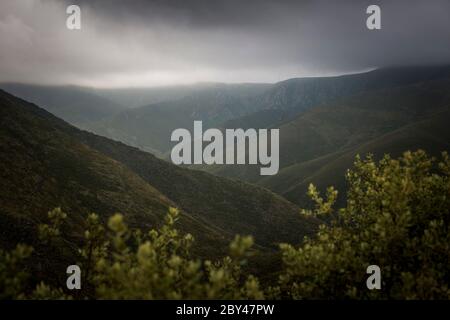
xmin=209 ymin=77 xmax=450 ymax=185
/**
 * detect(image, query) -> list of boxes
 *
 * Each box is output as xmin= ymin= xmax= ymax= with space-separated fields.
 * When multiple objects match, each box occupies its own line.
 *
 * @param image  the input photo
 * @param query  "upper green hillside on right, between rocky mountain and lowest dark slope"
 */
xmin=204 ymin=79 xmax=450 ymax=184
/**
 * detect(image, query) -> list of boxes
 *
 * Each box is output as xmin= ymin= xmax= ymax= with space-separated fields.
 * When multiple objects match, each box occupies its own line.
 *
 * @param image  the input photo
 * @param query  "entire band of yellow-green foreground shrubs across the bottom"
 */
xmin=0 ymin=151 xmax=450 ymax=299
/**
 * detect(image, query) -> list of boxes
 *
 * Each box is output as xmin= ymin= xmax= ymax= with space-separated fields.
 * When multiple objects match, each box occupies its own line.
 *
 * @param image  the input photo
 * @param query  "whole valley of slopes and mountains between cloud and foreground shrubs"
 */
xmin=0 ymin=67 xmax=450 ymax=282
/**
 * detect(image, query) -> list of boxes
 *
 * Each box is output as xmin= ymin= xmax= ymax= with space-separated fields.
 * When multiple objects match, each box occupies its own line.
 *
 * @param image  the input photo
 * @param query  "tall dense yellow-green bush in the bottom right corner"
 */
xmin=280 ymin=151 xmax=450 ymax=299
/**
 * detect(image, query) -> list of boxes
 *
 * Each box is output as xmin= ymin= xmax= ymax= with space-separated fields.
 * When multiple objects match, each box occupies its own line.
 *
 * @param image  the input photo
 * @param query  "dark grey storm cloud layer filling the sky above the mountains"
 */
xmin=0 ymin=0 xmax=450 ymax=86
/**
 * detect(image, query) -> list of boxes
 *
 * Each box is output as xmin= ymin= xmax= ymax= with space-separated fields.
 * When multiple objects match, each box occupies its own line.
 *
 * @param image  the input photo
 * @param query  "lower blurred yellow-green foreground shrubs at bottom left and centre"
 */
xmin=0 ymin=208 xmax=264 ymax=299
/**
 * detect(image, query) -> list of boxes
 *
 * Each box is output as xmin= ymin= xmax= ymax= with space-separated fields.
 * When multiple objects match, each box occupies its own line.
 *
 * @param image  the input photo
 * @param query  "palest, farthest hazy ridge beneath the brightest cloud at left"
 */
xmin=0 ymin=83 xmax=268 ymax=132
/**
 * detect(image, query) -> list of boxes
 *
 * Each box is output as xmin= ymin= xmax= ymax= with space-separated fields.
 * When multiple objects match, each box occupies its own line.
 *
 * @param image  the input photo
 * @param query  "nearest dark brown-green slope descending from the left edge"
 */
xmin=0 ymin=89 xmax=230 ymax=255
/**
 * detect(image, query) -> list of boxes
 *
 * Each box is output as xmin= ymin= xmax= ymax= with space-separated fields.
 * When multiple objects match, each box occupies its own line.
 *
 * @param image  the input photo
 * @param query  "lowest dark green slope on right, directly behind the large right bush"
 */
xmin=274 ymin=105 xmax=450 ymax=204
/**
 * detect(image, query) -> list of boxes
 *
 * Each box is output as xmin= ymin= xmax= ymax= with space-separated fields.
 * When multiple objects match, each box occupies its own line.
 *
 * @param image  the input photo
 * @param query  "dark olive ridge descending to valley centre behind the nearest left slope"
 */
xmin=70 ymin=125 xmax=317 ymax=250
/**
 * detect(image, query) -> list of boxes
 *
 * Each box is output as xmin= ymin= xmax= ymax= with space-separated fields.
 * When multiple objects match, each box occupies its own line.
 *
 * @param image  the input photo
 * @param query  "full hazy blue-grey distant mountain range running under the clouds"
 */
xmin=4 ymin=66 xmax=450 ymax=157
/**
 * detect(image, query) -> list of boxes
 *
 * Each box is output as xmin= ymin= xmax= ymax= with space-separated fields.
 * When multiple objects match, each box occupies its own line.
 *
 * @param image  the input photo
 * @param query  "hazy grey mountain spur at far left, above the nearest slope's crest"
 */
xmin=0 ymin=83 xmax=125 ymax=127
